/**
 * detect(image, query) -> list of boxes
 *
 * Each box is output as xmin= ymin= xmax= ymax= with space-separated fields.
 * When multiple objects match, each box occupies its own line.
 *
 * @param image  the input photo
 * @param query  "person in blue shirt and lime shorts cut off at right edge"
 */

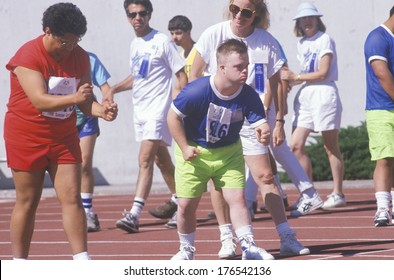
xmin=364 ymin=6 xmax=394 ymax=227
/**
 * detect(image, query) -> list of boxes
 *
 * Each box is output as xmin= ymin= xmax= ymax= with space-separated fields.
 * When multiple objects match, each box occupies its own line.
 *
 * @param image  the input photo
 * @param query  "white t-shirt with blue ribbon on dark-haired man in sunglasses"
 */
xmin=130 ymin=29 xmax=185 ymax=121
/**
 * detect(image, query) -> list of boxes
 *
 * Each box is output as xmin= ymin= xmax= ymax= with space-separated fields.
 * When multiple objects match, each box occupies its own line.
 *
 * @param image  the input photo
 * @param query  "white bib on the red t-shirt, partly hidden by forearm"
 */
xmin=42 ymin=77 xmax=77 ymax=119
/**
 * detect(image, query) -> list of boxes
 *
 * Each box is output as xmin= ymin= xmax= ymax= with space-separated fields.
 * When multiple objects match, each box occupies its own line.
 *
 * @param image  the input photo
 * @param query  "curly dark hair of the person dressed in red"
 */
xmin=42 ymin=3 xmax=87 ymax=37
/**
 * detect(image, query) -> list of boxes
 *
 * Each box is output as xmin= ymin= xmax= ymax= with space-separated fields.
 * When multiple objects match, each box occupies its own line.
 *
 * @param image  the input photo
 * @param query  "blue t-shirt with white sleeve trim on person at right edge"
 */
xmin=364 ymin=25 xmax=394 ymax=110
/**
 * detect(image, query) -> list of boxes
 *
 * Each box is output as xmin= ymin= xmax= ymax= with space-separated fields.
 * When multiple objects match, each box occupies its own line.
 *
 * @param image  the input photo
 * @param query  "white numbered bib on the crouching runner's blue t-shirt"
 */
xmin=206 ymin=103 xmax=232 ymax=143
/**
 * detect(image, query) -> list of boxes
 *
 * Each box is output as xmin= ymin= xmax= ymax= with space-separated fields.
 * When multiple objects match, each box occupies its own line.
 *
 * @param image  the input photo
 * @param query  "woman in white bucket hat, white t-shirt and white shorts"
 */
xmin=282 ymin=3 xmax=346 ymax=208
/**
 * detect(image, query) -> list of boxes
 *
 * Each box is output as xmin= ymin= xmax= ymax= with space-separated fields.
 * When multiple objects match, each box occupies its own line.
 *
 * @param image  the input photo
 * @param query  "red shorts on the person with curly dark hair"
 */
xmin=6 ymin=143 xmax=82 ymax=171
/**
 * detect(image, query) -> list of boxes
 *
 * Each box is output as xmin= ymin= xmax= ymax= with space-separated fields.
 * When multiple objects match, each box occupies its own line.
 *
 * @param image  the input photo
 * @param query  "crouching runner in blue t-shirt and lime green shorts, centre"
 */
xmin=167 ymin=39 xmax=273 ymax=260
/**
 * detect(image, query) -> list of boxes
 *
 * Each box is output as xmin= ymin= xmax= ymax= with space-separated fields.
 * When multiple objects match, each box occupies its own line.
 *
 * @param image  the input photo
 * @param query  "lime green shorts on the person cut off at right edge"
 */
xmin=366 ymin=110 xmax=394 ymax=160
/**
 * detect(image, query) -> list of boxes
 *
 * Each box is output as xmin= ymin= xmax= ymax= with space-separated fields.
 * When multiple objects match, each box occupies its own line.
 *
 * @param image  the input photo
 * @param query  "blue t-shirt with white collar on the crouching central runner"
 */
xmin=171 ymin=75 xmax=265 ymax=148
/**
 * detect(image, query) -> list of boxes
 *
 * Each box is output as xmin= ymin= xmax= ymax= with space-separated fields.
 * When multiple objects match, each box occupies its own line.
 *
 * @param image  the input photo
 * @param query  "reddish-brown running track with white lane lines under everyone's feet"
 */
xmin=0 ymin=181 xmax=394 ymax=260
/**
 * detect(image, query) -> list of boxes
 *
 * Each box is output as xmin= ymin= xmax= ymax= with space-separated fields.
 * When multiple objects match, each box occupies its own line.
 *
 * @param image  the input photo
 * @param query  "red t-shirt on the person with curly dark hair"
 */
xmin=4 ymin=35 xmax=90 ymax=147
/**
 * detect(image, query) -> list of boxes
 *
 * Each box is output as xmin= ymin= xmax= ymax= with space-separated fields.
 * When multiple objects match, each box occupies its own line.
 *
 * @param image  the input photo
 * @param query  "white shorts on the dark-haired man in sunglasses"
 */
xmin=134 ymin=119 xmax=172 ymax=146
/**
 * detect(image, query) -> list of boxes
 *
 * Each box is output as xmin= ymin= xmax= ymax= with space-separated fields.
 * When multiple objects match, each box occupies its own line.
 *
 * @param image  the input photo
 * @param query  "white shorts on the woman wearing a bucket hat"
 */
xmin=293 ymin=82 xmax=342 ymax=132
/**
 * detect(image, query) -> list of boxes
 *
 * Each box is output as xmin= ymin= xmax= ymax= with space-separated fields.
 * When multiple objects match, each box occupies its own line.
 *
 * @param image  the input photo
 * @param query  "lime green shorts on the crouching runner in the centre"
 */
xmin=174 ymin=140 xmax=245 ymax=198
